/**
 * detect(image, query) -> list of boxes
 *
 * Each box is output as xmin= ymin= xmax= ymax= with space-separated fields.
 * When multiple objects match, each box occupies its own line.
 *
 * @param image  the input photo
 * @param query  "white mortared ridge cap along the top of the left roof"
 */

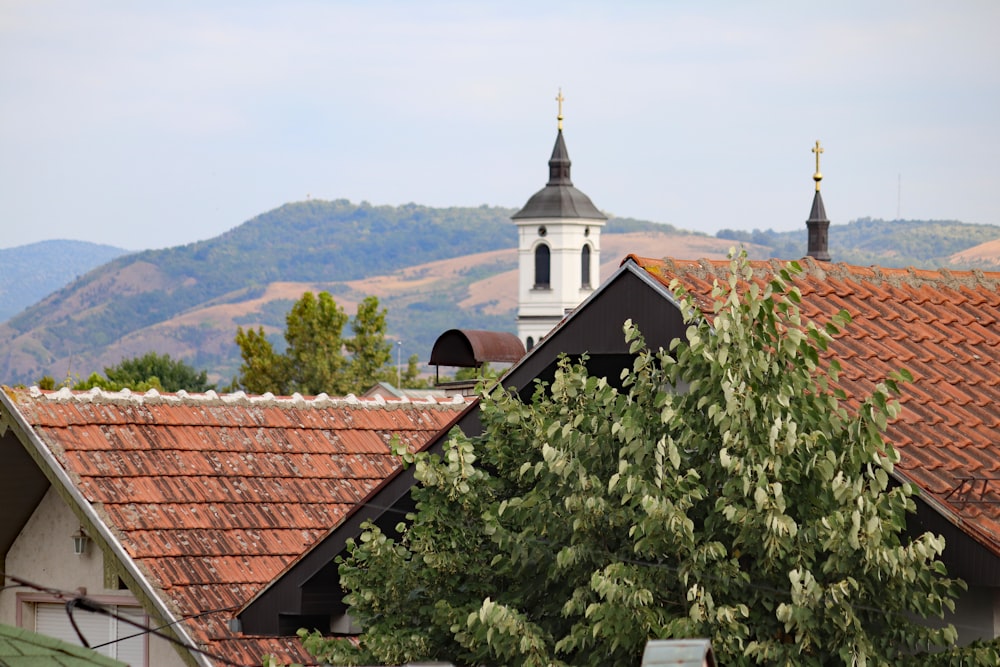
xmin=15 ymin=386 xmax=468 ymax=410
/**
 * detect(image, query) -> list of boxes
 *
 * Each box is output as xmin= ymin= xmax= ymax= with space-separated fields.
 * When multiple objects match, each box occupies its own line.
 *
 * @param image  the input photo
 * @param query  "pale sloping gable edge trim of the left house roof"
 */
xmin=0 ymin=388 xmax=213 ymax=667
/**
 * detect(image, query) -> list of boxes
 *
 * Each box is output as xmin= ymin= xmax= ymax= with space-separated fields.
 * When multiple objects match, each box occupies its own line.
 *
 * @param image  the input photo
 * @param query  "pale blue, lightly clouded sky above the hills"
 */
xmin=0 ymin=0 xmax=1000 ymax=250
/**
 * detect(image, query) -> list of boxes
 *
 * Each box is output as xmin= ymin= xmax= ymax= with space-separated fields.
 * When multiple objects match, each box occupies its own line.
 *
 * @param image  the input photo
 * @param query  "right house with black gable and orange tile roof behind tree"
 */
xmin=239 ymin=253 xmax=1000 ymax=642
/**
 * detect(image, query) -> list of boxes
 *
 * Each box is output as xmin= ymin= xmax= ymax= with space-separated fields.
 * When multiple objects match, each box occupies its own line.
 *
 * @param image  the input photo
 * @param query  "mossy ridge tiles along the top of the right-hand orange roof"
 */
xmin=622 ymin=253 xmax=1000 ymax=289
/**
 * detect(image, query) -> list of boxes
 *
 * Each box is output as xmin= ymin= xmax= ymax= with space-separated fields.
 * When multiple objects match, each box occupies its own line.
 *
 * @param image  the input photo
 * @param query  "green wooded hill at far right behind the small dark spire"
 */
xmin=716 ymin=218 xmax=1000 ymax=271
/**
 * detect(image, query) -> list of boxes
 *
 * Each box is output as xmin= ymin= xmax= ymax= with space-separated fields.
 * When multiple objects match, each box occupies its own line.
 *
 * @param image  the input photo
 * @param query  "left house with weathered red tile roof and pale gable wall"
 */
xmin=0 ymin=388 xmax=466 ymax=667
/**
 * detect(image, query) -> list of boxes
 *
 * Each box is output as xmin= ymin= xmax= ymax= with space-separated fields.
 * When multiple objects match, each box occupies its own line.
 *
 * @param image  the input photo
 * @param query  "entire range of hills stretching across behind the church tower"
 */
xmin=0 ymin=200 xmax=1000 ymax=384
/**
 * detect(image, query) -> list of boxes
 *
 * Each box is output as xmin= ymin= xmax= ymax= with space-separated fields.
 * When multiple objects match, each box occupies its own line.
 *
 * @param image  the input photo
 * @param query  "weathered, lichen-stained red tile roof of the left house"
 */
xmin=8 ymin=389 xmax=466 ymax=665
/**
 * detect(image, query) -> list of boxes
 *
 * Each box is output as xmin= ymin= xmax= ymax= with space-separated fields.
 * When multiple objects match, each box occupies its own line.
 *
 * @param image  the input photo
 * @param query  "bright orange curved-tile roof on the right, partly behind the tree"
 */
xmin=626 ymin=256 xmax=1000 ymax=555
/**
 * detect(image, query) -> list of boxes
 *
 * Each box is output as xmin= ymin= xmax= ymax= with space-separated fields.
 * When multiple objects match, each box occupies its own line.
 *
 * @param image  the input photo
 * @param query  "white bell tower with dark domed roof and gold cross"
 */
xmin=512 ymin=90 xmax=607 ymax=350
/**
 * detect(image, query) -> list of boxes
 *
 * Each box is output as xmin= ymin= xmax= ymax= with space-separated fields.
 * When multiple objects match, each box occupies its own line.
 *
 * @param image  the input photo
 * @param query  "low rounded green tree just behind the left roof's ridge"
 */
xmin=69 ymin=352 xmax=215 ymax=392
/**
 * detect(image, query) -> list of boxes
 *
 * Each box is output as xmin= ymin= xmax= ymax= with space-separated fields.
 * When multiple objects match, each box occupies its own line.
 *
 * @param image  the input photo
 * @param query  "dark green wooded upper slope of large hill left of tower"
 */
xmin=9 ymin=199 xmax=514 ymax=334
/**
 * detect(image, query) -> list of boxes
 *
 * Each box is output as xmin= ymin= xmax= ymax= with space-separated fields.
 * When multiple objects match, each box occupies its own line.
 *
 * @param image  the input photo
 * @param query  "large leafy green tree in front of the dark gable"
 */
xmin=300 ymin=256 xmax=984 ymax=666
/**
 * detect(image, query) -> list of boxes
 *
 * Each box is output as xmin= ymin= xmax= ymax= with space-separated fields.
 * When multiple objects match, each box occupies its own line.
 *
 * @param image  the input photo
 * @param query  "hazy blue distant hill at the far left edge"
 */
xmin=0 ymin=241 xmax=128 ymax=322
